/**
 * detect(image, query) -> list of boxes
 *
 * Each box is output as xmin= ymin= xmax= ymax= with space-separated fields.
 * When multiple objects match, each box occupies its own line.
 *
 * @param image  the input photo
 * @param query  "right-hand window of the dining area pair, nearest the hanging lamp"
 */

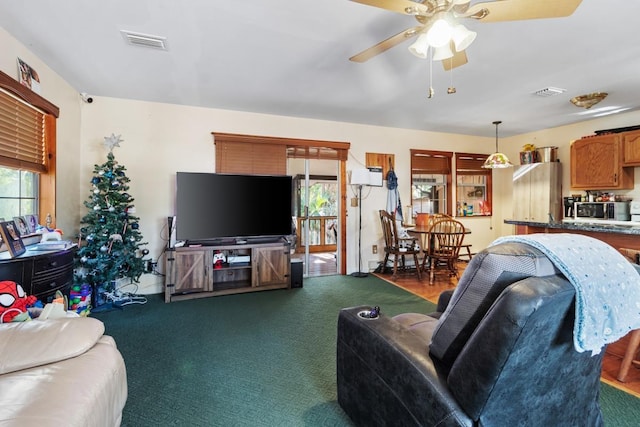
xmin=456 ymin=153 xmax=492 ymax=216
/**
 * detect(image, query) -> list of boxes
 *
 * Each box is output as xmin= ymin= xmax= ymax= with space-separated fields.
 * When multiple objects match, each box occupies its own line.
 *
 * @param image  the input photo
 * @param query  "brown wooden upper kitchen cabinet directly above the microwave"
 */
xmin=571 ymin=134 xmax=634 ymax=190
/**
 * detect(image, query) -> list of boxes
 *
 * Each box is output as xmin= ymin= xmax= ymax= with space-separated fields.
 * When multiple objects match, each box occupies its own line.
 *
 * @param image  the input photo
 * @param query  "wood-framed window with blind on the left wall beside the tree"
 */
xmin=0 ymin=71 xmax=59 ymax=227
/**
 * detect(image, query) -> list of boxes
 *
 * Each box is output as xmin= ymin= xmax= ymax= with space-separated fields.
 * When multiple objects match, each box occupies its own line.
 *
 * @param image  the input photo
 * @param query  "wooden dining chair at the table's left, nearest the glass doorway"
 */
xmin=379 ymin=210 xmax=422 ymax=280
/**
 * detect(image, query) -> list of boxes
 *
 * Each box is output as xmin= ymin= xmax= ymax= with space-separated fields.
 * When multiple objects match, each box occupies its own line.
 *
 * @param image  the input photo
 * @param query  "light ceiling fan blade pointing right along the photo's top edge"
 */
xmin=465 ymin=0 xmax=582 ymax=22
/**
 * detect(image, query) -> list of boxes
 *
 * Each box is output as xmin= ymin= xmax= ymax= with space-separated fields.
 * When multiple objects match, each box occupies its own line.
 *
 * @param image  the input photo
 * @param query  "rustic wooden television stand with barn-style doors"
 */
xmin=165 ymin=239 xmax=291 ymax=303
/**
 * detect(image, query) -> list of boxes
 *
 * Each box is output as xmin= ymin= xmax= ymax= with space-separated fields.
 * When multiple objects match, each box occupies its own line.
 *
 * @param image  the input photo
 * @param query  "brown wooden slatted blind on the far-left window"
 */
xmin=0 ymin=90 xmax=47 ymax=173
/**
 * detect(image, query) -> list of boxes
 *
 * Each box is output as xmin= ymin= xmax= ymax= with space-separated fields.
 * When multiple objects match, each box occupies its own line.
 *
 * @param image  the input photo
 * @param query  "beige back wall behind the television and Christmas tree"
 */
xmin=80 ymin=97 xmax=500 ymax=290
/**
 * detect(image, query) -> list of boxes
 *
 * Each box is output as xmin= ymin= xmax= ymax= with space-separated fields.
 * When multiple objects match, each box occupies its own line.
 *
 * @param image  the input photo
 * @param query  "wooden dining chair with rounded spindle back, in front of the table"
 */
xmin=427 ymin=218 xmax=465 ymax=285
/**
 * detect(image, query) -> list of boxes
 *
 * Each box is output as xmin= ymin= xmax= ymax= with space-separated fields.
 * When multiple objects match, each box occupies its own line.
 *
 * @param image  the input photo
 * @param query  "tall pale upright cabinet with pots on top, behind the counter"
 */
xmin=513 ymin=162 xmax=562 ymax=222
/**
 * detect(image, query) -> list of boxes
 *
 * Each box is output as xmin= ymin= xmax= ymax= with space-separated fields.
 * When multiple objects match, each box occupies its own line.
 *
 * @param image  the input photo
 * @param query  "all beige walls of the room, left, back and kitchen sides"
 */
xmin=0 ymin=25 xmax=640 ymax=292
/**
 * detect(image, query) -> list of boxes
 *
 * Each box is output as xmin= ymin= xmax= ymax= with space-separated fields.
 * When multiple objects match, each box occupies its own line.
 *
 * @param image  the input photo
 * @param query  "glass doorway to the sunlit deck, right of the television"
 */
xmin=287 ymin=158 xmax=340 ymax=277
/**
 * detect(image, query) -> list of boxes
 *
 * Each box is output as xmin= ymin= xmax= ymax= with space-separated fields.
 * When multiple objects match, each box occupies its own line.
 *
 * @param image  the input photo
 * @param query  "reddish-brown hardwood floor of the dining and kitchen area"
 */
xmin=376 ymin=262 xmax=640 ymax=397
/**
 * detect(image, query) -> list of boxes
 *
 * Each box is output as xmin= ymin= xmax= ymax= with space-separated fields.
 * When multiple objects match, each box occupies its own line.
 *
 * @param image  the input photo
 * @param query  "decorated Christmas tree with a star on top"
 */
xmin=75 ymin=134 xmax=149 ymax=307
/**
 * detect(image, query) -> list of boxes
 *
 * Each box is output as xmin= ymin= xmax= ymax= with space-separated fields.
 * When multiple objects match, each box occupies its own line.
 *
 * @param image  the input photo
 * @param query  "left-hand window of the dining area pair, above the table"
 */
xmin=411 ymin=150 xmax=453 ymax=215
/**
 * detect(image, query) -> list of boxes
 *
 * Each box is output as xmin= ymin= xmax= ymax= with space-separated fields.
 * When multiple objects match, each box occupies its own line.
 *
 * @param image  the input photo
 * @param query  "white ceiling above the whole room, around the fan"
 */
xmin=0 ymin=0 xmax=640 ymax=137
